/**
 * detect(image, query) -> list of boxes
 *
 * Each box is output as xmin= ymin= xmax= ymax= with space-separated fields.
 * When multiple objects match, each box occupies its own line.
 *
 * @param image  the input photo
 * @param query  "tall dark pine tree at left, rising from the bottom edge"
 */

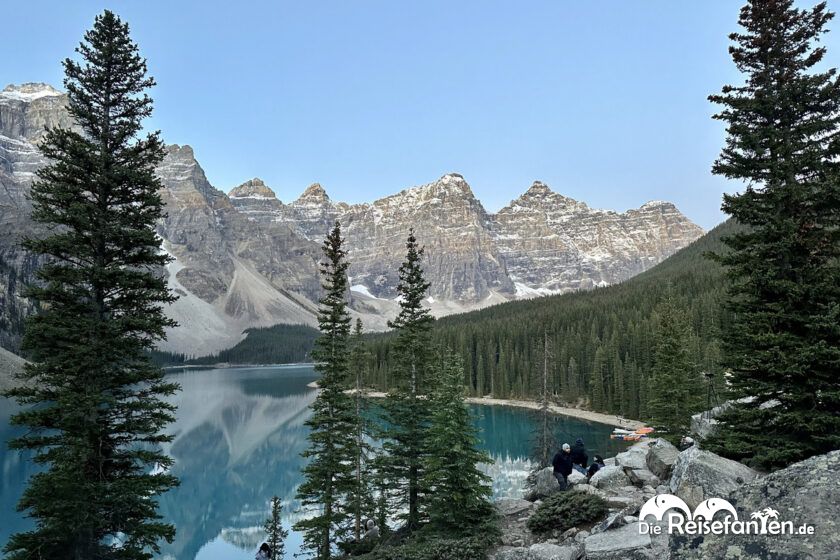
xmin=5 ymin=11 xmax=177 ymax=560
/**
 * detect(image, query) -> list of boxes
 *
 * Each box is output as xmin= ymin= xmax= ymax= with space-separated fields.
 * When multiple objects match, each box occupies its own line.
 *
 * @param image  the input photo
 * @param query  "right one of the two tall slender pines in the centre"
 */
xmin=380 ymin=229 xmax=434 ymax=530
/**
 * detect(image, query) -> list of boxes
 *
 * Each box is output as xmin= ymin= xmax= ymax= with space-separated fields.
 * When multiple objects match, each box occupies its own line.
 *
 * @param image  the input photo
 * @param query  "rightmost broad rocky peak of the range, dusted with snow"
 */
xmin=493 ymin=181 xmax=702 ymax=295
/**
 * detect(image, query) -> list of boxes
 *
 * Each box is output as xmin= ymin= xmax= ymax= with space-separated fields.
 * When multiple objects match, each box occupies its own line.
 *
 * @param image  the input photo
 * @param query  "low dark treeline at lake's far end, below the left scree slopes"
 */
xmin=151 ymin=325 xmax=319 ymax=366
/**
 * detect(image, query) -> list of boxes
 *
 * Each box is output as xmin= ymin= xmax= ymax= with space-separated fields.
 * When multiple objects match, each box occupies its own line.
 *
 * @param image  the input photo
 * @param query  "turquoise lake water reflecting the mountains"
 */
xmin=0 ymin=366 xmax=625 ymax=560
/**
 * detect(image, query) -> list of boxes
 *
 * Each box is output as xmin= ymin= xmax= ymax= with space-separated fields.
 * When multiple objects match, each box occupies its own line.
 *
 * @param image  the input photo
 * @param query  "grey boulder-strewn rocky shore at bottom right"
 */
xmin=489 ymin=439 xmax=840 ymax=560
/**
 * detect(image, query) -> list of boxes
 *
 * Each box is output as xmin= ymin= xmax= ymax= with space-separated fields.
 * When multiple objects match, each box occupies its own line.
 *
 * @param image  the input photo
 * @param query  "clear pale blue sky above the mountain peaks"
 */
xmin=0 ymin=0 xmax=840 ymax=228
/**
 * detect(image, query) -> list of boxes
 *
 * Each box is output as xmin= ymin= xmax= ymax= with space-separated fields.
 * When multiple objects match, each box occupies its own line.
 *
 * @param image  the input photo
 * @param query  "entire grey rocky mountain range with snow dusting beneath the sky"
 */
xmin=0 ymin=84 xmax=703 ymax=355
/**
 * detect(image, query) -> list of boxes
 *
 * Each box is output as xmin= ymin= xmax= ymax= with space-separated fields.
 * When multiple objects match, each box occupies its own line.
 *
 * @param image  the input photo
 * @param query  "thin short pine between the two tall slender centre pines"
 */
xmin=348 ymin=319 xmax=376 ymax=542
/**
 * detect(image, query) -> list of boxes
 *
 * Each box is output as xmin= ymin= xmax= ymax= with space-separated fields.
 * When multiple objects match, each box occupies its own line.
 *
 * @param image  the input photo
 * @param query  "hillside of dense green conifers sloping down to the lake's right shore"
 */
xmin=360 ymin=221 xmax=737 ymax=418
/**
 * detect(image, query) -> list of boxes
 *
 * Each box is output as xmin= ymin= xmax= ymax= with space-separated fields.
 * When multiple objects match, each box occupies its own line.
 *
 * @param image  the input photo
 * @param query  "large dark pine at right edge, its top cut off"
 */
xmin=710 ymin=0 xmax=840 ymax=468
